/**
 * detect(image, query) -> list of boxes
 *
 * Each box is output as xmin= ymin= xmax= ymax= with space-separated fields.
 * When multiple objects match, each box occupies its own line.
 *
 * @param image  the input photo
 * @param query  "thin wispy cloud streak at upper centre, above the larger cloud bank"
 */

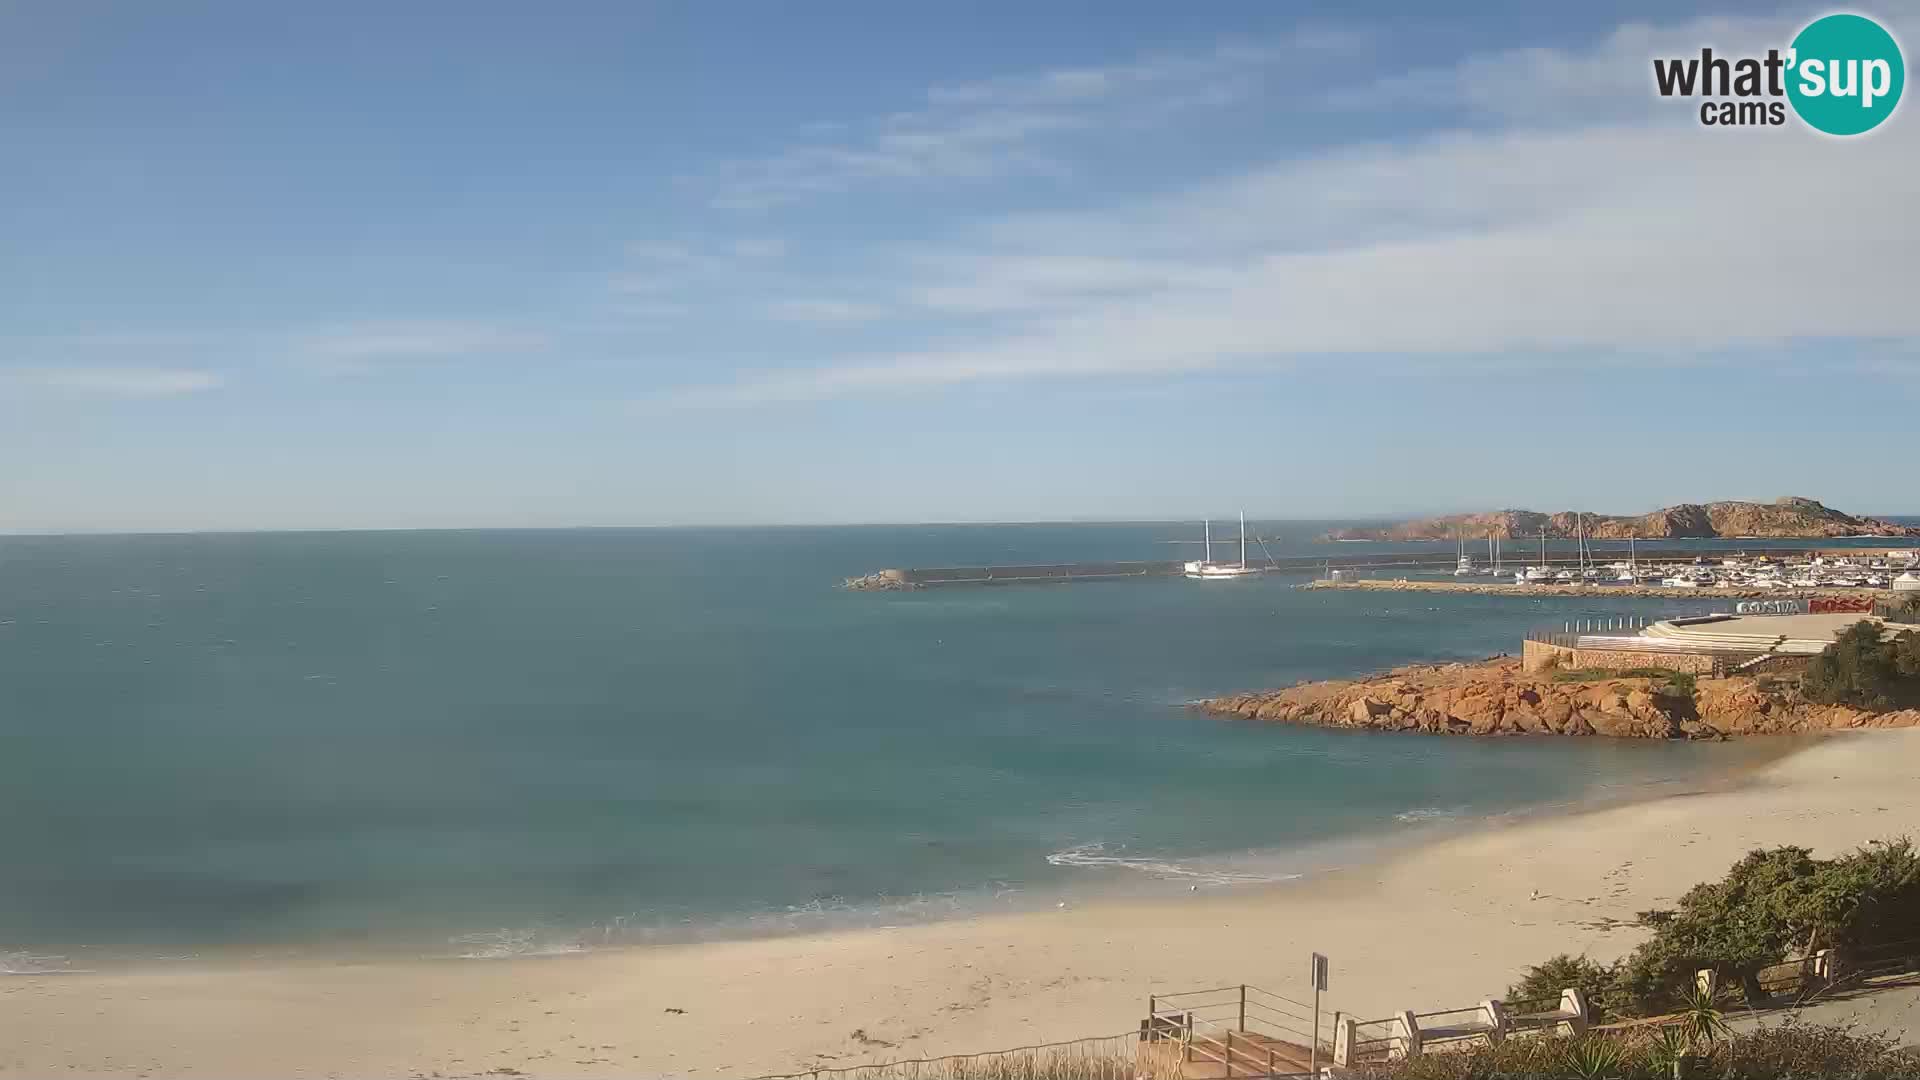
xmin=701 ymin=31 xmax=1365 ymax=209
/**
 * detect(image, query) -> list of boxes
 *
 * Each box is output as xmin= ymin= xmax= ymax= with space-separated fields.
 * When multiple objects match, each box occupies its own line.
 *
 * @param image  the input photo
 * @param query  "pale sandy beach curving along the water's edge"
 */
xmin=0 ymin=730 xmax=1920 ymax=1076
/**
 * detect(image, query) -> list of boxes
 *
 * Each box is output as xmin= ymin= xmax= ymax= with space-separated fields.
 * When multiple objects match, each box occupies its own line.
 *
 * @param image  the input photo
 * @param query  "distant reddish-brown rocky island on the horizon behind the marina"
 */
xmin=1327 ymin=496 xmax=1920 ymax=540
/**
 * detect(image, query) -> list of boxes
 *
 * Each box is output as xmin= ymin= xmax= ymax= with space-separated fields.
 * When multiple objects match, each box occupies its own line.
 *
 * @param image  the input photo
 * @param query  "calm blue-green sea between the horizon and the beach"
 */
xmin=0 ymin=521 xmax=1912 ymax=960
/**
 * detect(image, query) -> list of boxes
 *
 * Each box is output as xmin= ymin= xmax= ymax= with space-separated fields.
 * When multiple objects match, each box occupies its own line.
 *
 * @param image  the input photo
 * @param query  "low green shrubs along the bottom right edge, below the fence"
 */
xmin=1354 ymin=1020 xmax=1920 ymax=1080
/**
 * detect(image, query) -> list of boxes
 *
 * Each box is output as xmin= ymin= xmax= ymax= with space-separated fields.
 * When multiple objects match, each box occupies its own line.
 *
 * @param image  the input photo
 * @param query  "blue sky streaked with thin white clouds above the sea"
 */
xmin=0 ymin=0 xmax=1920 ymax=530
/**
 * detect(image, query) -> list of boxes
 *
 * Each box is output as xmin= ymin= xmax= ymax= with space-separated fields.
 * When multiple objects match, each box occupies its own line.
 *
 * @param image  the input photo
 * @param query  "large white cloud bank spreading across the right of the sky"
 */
xmin=674 ymin=2 xmax=1920 ymax=404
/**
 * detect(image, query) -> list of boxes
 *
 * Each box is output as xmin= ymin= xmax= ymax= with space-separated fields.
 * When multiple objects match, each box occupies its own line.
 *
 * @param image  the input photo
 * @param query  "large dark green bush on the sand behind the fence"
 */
xmin=1507 ymin=840 xmax=1920 ymax=1019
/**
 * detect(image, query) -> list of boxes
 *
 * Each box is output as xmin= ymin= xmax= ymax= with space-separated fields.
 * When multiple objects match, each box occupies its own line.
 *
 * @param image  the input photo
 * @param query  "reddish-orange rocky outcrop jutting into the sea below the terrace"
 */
xmin=1194 ymin=657 xmax=1920 ymax=738
